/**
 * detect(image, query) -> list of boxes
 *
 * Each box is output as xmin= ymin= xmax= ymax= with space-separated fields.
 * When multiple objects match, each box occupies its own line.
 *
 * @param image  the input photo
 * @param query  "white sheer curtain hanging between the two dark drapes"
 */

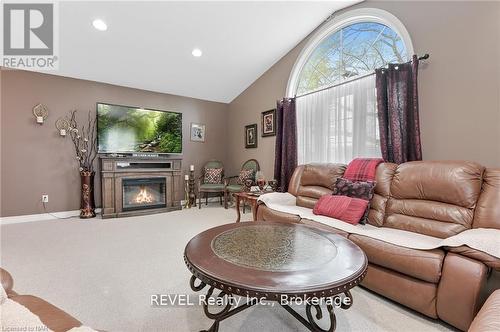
xmin=296 ymin=75 xmax=381 ymax=164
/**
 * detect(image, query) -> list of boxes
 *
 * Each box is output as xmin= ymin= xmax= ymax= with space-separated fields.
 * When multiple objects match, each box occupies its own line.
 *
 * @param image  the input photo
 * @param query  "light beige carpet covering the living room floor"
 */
xmin=0 ymin=207 xmax=458 ymax=332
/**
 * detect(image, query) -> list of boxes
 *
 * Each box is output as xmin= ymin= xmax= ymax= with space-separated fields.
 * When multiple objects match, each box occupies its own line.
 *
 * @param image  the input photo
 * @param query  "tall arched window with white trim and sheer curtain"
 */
xmin=287 ymin=9 xmax=413 ymax=163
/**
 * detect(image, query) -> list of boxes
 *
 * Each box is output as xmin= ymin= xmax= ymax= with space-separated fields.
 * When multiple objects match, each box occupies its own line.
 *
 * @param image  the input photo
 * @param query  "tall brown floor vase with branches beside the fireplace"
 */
xmin=69 ymin=110 xmax=97 ymax=218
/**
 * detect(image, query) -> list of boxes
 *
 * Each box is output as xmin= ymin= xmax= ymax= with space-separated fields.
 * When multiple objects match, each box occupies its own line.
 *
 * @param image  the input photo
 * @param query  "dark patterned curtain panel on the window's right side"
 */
xmin=375 ymin=55 xmax=422 ymax=164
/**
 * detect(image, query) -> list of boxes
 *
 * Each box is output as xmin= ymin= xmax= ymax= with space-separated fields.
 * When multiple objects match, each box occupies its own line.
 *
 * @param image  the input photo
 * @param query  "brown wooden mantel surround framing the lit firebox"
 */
xmin=100 ymin=156 xmax=183 ymax=218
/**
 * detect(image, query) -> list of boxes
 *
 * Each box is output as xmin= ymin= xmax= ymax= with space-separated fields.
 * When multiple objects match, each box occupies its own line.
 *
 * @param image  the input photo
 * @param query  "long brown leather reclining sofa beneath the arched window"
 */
xmin=257 ymin=161 xmax=500 ymax=331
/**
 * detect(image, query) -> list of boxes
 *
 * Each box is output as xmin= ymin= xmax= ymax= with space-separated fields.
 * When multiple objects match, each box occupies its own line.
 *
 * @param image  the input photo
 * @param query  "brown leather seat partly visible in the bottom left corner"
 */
xmin=0 ymin=268 xmax=82 ymax=332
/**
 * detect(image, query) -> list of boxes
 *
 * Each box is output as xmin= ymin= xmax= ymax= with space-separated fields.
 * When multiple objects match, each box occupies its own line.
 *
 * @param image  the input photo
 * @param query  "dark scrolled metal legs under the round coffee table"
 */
xmin=189 ymin=275 xmax=352 ymax=332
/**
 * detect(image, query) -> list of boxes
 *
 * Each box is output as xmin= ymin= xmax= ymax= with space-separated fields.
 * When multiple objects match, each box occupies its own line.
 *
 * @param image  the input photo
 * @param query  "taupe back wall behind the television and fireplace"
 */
xmin=0 ymin=70 xmax=228 ymax=216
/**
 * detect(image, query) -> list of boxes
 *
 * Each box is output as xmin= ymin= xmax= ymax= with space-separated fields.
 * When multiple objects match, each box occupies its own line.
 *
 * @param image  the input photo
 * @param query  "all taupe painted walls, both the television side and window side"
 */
xmin=0 ymin=1 xmax=500 ymax=216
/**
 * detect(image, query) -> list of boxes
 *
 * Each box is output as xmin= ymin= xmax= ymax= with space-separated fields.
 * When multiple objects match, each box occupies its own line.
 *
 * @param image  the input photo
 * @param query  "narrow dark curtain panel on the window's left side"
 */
xmin=274 ymin=98 xmax=297 ymax=192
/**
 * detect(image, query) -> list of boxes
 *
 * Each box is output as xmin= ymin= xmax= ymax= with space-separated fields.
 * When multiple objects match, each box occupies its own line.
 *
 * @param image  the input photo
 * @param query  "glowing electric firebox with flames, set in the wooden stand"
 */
xmin=122 ymin=177 xmax=167 ymax=211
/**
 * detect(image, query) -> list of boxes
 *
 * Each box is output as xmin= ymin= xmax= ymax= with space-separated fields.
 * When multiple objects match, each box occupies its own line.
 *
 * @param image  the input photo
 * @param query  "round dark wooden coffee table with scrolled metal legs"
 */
xmin=184 ymin=221 xmax=368 ymax=331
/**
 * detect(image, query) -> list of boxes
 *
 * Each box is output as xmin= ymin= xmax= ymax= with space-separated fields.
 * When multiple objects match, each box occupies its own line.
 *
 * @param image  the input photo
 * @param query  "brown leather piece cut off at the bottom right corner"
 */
xmin=469 ymin=289 xmax=500 ymax=332
